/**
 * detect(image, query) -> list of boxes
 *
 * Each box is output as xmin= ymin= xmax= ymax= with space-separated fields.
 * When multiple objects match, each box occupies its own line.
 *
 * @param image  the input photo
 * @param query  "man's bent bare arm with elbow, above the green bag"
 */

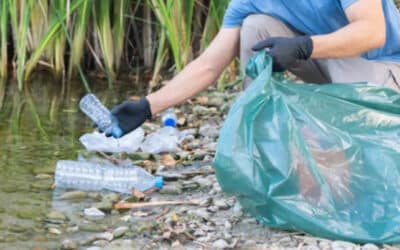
xmin=311 ymin=0 xmax=386 ymax=58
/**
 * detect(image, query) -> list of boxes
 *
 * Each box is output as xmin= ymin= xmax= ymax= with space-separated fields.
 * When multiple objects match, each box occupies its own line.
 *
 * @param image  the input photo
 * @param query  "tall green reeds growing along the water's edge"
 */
xmin=0 ymin=0 xmax=234 ymax=89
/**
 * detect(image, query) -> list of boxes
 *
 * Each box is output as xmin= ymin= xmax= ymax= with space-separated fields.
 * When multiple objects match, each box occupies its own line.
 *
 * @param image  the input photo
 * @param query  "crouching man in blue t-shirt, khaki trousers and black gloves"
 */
xmin=108 ymin=0 xmax=400 ymax=138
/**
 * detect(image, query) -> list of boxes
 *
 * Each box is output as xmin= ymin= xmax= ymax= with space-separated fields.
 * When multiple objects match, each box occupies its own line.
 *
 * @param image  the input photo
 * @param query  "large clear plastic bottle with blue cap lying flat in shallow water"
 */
xmin=54 ymin=160 xmax=163 ymax=194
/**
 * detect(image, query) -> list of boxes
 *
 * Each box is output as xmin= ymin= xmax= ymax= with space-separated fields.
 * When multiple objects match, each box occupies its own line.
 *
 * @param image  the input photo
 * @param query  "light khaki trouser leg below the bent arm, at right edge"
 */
xmin=316 ymin=57 xmax=400 ymax=92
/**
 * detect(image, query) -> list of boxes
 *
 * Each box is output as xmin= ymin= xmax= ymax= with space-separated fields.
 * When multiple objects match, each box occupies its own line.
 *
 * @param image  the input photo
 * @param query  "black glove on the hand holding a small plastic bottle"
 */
xmin=107 ymin=98 xmax=151 ymax=136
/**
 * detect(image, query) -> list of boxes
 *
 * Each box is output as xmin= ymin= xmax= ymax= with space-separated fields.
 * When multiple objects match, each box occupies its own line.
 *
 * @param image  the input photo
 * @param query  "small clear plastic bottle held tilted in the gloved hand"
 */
xmin=79 ymin=94 xmax=122 ymax=138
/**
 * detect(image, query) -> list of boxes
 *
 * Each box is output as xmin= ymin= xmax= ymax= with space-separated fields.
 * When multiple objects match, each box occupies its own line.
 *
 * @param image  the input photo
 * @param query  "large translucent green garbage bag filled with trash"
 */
xmin=213 ymin=52 xmax=400 ymax=243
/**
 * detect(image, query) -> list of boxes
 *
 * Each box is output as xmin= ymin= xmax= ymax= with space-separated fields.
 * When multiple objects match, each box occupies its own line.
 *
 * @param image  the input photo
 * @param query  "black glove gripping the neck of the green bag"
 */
xmin=252 ymin=36 xmax=313 ymax=72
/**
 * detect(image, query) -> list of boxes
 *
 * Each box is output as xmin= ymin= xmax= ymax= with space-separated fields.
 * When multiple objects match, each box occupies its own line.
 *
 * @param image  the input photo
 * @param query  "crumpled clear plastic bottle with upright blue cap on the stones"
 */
xmin=140 ymin=109 xmax=179 ymax=154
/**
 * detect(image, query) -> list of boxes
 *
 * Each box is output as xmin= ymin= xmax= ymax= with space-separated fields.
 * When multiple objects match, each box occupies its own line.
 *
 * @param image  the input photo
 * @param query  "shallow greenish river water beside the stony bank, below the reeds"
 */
xmin=0 ymin=77 xmax=143 ymax=249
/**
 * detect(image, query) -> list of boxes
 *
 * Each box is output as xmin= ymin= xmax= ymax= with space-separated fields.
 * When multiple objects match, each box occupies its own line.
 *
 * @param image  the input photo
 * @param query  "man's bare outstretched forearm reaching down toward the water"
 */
xmin=147 ymin=28 xmax=240 ymax=115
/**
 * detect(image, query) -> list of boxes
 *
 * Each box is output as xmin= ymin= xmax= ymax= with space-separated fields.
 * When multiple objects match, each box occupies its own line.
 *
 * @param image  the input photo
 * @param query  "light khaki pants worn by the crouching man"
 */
xmin=240 ymin=14 xmax=400 ymax=92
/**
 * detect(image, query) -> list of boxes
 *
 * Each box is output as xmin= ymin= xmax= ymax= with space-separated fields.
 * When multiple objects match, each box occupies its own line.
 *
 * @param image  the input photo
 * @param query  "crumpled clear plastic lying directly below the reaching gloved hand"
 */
xmin=79 ymin=128 xmax=144 ymax=153
